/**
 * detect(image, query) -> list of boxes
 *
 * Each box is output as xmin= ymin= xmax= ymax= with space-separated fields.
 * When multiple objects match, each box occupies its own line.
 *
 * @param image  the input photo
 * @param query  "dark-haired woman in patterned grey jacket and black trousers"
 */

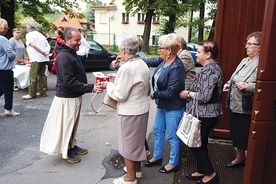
xmin=180 ymin=41 xmax=223 ymax=184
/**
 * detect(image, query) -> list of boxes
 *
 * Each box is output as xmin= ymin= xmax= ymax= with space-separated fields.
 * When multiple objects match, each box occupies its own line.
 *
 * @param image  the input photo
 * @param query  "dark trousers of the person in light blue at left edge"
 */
xmin=0 ymin=70 xmax=14 ymax=110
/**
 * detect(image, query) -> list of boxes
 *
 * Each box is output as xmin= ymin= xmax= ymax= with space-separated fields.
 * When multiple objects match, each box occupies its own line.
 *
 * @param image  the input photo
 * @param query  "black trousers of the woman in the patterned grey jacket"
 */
xmin=190 ymin=117 xmax=218 ymax=175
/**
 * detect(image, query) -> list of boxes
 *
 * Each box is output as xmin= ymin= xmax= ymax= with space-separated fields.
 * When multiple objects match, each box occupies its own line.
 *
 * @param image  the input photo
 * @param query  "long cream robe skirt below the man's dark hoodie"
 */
xmin=40 ymin=96 xmax=82 ymax=159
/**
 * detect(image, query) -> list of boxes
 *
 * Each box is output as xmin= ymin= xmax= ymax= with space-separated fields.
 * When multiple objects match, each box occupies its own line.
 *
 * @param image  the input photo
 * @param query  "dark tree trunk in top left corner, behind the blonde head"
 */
xmin=1 ymin=0 xmax=15 ymax=39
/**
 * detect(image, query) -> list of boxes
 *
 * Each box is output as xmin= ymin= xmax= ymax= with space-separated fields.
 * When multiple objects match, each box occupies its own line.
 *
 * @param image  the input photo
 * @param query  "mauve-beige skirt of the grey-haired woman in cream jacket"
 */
xmin=118 ymin=112 xmax=149 ymax=161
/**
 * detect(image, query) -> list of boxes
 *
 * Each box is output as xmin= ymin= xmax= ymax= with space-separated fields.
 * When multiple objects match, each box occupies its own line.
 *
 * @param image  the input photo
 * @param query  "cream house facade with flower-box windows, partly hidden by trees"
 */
xmin=92 ymin=0 xmax=188 ymax=45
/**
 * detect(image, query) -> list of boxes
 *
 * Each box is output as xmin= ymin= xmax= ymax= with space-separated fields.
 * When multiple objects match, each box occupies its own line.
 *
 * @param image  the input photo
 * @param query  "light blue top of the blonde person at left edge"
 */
xmin=0 ymin=35 xmax=16 ymax=70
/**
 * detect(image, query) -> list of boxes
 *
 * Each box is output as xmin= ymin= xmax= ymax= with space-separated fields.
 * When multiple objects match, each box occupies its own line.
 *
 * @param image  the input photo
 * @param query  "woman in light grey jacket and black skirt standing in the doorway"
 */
xmin=224 ymin=32 xmax=262 ymax=168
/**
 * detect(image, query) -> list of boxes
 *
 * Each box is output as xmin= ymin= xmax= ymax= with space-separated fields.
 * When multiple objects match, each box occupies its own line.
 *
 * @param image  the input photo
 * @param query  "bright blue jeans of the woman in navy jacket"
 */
xmin=153 ymin=108 xmax=184 ymax=167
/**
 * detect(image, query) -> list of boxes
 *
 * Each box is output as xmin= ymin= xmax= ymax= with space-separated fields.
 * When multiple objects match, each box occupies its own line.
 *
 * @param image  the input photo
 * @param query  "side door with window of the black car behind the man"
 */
xmin=84 ymin=41 xmax=109 ymax=69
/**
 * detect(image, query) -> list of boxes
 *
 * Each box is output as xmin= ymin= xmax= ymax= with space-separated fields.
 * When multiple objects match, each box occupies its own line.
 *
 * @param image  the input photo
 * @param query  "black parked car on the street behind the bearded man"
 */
xmin=47 ymin=38 xmax=117 ymax=70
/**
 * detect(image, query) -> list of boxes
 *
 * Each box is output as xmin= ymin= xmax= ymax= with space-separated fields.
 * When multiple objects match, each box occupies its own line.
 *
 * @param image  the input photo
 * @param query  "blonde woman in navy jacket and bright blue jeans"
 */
xmin=145 ymin=33 xmax=186 ymax=173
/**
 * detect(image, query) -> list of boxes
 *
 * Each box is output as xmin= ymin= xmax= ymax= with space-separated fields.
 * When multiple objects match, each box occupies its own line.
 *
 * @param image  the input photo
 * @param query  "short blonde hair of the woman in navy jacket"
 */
xmin=158 ymin=33 xmax=181 ymax=55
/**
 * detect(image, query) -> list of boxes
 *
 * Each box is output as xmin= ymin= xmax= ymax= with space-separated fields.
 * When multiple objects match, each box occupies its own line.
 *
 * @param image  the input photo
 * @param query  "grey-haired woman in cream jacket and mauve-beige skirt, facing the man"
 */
xmin=106 ymin=34 xmax=150 ymax=184
